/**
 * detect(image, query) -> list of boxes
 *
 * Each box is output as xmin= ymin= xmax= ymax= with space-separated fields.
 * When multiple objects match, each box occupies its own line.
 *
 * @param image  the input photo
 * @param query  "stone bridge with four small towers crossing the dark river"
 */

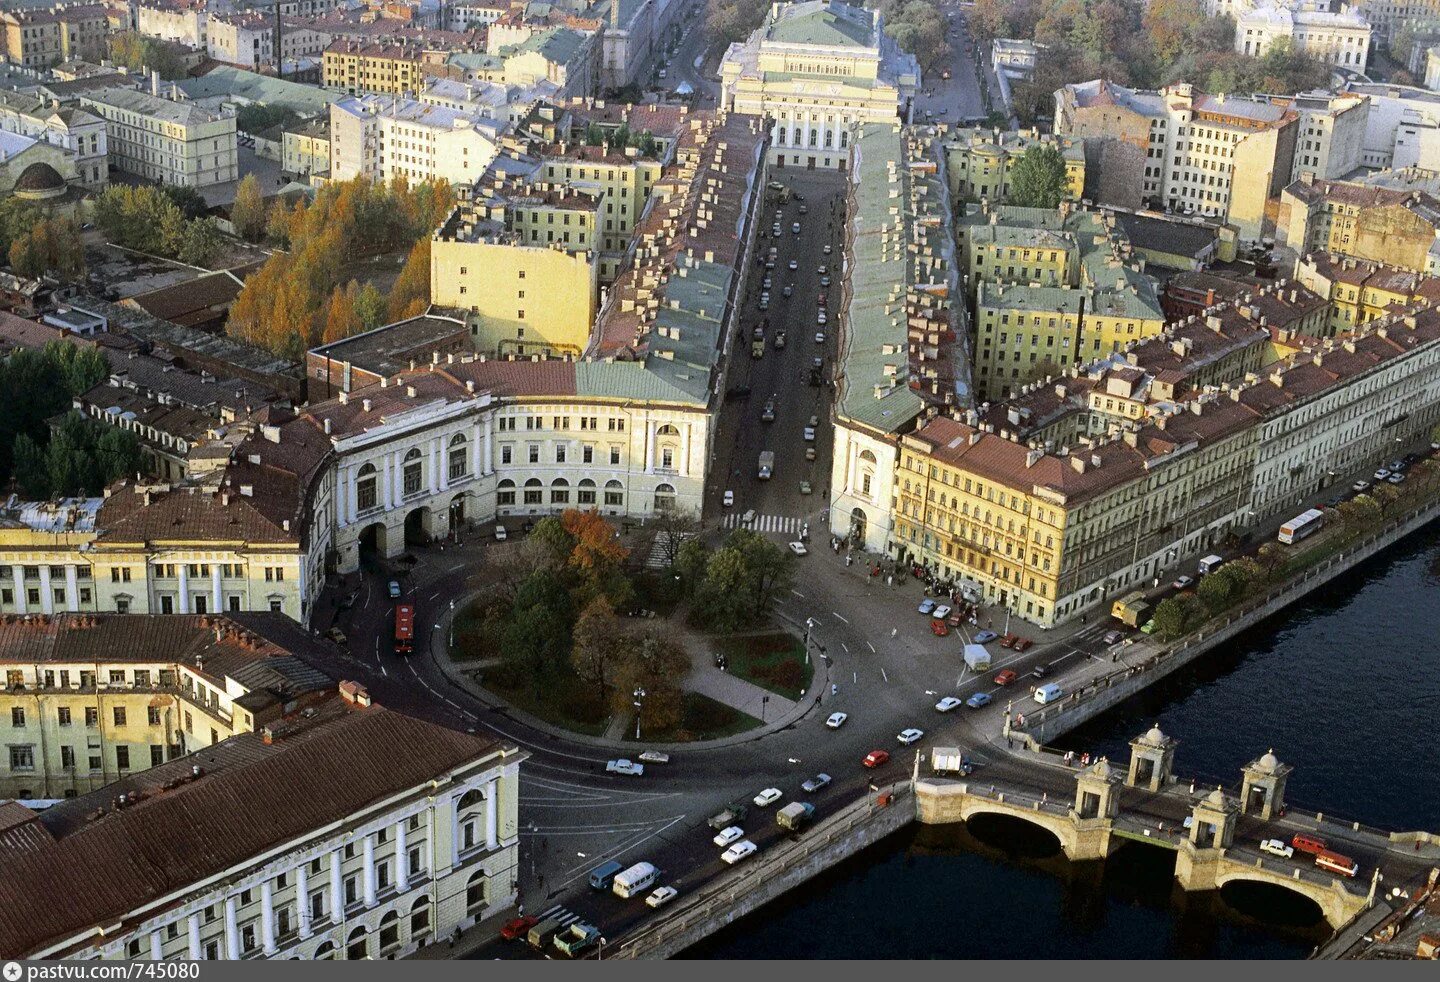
xmin=914 ymin=727 xmax=1440 ymax=929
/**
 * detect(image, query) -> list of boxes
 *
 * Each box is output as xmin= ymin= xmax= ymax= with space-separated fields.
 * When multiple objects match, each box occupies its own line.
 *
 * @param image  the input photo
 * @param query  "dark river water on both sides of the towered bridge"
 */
xmin=688 ymin=530 xmax=1440 ymax=959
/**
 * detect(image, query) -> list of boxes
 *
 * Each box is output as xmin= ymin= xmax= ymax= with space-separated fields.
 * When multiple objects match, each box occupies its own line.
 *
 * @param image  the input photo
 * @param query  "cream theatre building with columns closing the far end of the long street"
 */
xmin=720 ymin=0 xmax=920 ymax=167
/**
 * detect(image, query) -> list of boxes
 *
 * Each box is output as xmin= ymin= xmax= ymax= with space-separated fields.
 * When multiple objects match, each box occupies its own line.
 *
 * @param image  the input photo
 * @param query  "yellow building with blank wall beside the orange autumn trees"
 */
xmin=431 ymin=184 xmax=603 ymax=354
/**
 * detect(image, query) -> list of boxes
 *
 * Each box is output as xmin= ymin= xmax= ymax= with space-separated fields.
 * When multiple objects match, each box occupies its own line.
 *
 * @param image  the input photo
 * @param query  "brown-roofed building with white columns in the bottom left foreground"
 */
xmin=0 ymin=683 xmax=526 ymax=960
